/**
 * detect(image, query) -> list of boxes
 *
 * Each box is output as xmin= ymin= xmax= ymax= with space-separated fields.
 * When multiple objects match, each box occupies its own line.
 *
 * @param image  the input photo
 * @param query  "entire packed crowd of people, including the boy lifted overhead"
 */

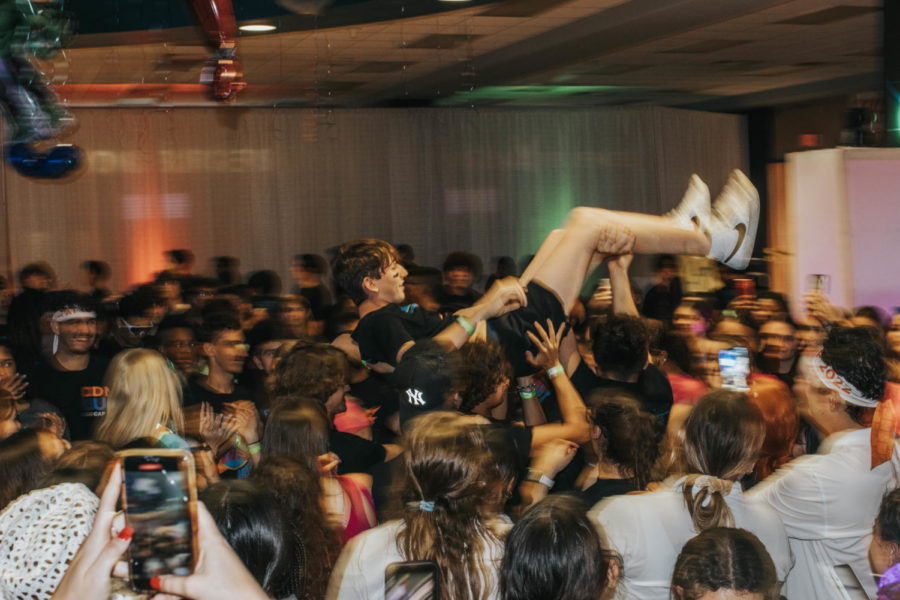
xmin=0 ymin=173 xmax=900 ymax=600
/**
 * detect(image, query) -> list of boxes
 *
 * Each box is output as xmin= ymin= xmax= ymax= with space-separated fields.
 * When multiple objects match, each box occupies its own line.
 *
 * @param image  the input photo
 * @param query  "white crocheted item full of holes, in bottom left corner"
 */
xmin=0 ymin=483 xmax=100 ymax=600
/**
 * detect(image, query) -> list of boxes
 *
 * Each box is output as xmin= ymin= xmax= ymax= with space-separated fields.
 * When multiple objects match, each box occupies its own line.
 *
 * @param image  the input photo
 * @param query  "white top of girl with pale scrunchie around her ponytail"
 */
xmin=588 ymin=477 xmax=793 ymax=600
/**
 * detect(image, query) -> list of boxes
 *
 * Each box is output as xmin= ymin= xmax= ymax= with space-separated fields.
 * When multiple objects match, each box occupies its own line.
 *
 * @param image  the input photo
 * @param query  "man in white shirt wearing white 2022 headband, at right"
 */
xmin=748 ymin=327 xmax=900 ymax=600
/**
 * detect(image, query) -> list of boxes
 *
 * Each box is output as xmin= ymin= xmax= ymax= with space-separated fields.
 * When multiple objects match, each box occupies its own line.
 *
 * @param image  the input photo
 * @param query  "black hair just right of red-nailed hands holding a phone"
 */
xmin=199 ymin=480 xmax=300 ymax=598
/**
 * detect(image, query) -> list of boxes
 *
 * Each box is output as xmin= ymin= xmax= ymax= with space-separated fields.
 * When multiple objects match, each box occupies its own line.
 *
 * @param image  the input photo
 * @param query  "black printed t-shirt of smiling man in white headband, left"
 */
xmin=28 ymin=354 xmax=109 ymax=441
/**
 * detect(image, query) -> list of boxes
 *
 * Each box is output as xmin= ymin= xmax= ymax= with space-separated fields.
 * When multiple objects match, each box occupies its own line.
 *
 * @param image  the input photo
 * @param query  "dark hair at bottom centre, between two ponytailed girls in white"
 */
xmin=500 ymin=494 xmax=612 ymax=600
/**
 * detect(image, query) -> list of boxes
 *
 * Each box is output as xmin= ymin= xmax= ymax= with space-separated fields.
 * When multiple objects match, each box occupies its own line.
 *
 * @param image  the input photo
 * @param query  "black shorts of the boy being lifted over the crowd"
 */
xmin=487 ymin=281 xmax=566 ymax=377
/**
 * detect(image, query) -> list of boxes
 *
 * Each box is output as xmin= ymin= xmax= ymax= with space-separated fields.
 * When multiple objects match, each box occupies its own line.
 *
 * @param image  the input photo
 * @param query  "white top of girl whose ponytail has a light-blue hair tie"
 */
xmin=328 ymin=519 xmax=510 ymax=600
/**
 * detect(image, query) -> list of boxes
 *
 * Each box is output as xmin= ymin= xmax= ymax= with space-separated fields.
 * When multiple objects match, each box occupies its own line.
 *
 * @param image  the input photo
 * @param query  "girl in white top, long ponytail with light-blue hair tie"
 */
xmin=328 ymin=411 xmax=511 ymax=600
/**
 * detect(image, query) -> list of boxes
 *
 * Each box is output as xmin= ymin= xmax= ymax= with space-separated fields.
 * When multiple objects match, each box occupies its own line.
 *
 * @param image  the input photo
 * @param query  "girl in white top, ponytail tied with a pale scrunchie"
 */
xmin=589 ymin=390 xmax=793 ymax=600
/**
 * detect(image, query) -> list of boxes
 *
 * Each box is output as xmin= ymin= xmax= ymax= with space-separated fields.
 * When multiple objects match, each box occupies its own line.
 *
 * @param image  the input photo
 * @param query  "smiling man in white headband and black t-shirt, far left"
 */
xmin=27 ymin=291 xmax=109 ymax=441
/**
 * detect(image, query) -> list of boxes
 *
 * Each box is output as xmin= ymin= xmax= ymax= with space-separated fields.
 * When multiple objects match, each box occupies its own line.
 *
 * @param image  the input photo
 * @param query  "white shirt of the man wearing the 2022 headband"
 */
xmin=747 ymin=428 xmax=900 ymax=600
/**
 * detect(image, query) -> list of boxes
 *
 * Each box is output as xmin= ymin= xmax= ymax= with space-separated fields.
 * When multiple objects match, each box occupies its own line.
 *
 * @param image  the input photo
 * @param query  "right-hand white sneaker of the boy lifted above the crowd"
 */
xmin=707 ymin=169 xmax=759 ymax=270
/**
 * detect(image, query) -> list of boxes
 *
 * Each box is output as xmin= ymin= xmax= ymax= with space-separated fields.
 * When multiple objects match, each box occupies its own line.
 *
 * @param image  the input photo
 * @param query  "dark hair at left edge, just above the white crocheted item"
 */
xmin=0 ymin=429 xmax=52 ymax=510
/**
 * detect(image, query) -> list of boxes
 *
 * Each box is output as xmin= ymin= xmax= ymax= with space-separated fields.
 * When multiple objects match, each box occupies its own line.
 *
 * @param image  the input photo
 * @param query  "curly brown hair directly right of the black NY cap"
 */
xmin=458 ymin=342 xmax=512 ymax=414
